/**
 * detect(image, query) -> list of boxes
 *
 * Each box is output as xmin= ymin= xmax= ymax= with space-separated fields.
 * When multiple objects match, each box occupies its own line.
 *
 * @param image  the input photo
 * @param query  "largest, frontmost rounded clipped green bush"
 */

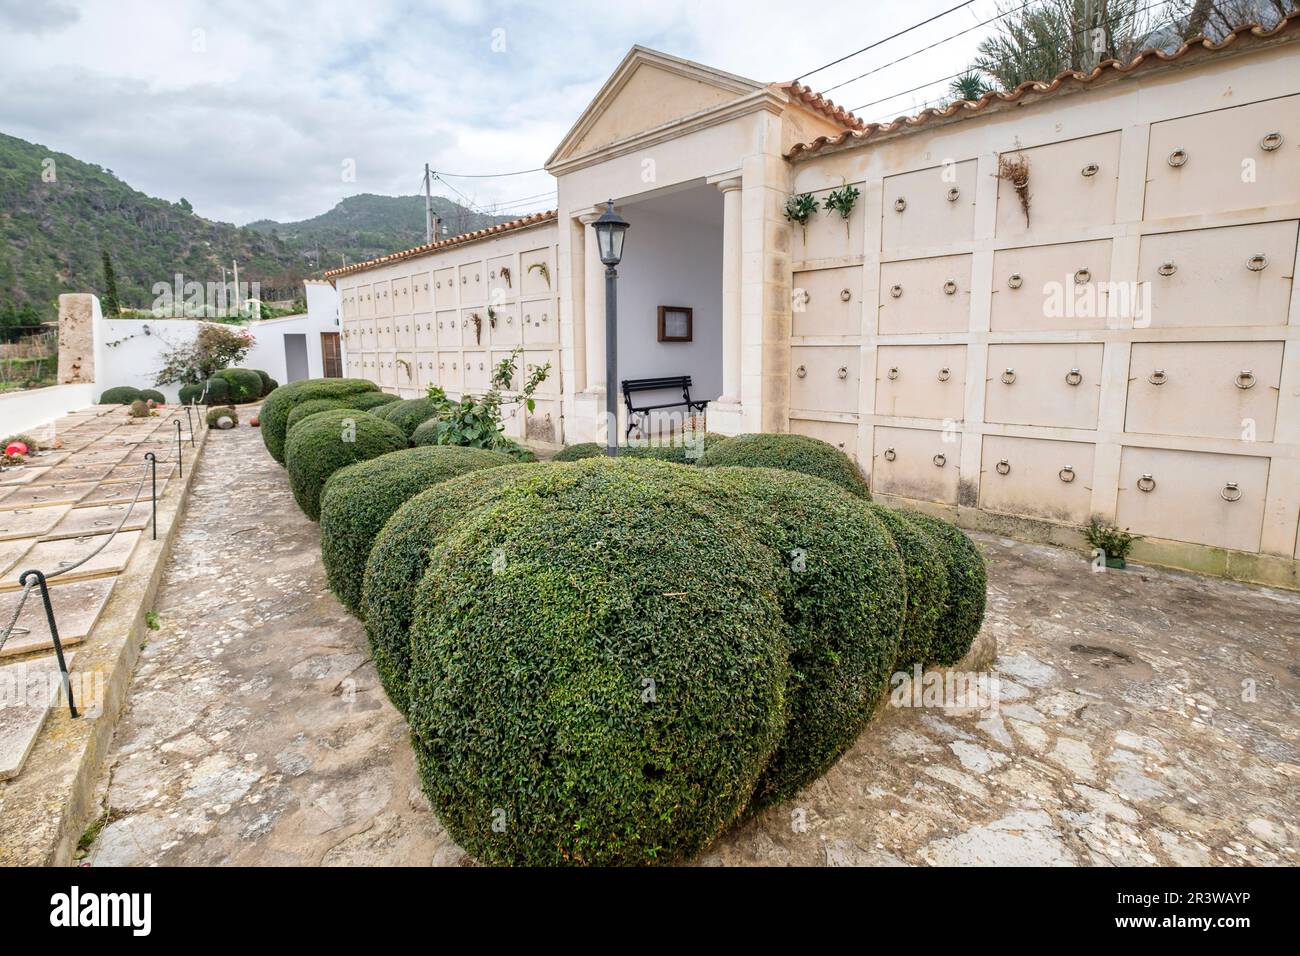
xmin=408 ymin=460 xmax=788 ymax=865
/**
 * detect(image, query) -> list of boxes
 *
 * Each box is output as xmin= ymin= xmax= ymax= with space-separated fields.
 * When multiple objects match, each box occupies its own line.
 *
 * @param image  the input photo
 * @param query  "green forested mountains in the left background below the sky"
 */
xmin=0 ymin=133 xmax=508 ymax=320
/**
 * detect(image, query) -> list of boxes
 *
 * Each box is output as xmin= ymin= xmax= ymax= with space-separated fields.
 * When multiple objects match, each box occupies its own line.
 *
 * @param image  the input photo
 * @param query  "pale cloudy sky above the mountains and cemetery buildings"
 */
xmin=0 ymin=0 xmax=1008 ymax=224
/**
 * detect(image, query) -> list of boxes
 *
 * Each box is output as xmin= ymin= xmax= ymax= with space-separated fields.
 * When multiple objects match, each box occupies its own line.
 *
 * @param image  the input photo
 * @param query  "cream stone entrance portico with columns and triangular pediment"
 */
xmin=546 ymin=47 xmax=844 ymax=442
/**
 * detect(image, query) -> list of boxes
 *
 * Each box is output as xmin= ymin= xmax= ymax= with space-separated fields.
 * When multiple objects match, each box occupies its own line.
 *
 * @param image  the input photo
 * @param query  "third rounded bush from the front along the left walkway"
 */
xmin=319 ymin=444 xmax=511 ymax=617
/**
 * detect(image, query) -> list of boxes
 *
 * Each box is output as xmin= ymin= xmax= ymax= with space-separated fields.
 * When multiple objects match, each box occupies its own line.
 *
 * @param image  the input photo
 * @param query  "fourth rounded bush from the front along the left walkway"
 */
xmin=284 ymin=408 xmax=406 ymax=522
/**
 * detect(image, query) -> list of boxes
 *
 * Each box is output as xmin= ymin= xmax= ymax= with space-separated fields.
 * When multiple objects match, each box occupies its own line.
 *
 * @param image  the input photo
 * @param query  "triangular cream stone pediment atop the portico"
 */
xmin=546 ymin=47 xmax=763 ymax=166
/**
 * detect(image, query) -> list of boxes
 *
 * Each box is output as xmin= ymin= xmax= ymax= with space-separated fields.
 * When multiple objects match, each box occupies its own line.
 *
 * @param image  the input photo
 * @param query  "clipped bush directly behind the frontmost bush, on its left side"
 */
xmin=360 ymin=463 xmax=530 ymax=714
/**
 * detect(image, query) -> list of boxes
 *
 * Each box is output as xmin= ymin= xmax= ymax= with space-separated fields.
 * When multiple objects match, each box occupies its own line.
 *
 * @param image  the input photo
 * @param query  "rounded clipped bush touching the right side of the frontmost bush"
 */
xmin=703 ymin=468 xmax=906 ymax=809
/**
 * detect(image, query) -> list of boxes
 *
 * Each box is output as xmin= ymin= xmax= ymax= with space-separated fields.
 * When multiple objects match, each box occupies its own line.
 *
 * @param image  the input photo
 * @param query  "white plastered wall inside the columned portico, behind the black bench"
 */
xmin=616 ymin=186 xmax=723 ymax=418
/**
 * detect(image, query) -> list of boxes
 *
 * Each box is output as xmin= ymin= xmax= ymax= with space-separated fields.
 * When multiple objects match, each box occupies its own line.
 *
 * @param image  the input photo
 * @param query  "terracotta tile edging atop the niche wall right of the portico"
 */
xmin=785 ymin=10 xmax=1300 ymax=159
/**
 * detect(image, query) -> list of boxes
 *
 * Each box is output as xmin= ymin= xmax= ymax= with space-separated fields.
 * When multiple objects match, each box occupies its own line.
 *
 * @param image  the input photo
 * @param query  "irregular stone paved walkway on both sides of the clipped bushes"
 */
xmin=88 ymin=418 xmax=1300 ymax=866
